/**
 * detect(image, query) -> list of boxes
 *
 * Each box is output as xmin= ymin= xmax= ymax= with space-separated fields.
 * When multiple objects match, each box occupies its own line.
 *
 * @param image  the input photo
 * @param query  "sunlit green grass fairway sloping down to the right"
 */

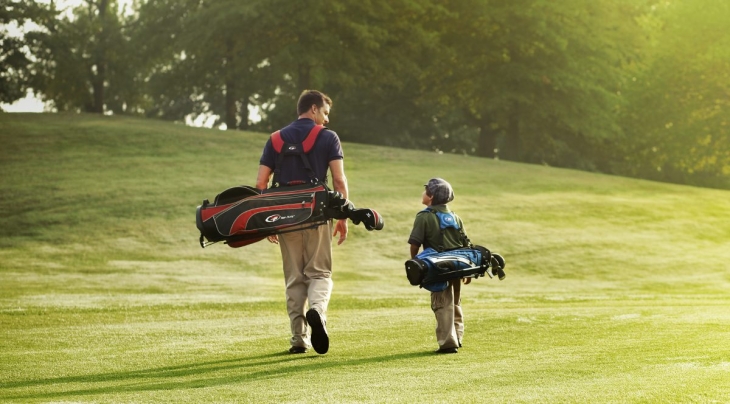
xmin=0 ymin=114 xmax=730 ymax=403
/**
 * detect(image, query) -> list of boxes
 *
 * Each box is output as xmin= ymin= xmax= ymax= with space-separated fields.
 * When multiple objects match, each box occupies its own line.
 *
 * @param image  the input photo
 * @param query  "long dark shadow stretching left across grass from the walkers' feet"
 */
xmin=0 ymin=352 xmax=434 ymax=400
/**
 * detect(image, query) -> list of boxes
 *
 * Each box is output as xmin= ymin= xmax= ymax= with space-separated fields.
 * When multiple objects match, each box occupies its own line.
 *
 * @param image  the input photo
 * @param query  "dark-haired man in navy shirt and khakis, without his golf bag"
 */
xmin=256 ymin=90 xmax=348 ymax=354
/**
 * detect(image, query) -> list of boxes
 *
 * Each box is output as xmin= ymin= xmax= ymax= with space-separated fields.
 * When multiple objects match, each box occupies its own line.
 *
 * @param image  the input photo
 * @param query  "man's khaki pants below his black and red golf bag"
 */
xmin=279 ymin=221 xmax=333 ymax=348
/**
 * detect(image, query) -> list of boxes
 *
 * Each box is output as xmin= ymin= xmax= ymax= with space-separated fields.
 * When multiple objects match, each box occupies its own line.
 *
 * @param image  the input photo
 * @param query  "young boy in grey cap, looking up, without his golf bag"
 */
xmin=408 ymin=178 xmax=471 ymax=353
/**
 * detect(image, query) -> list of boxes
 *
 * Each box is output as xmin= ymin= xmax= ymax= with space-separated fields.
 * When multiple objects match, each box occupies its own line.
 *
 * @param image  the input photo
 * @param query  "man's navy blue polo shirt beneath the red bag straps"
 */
xmin=259 ymin=118 xmax=344 ymax=184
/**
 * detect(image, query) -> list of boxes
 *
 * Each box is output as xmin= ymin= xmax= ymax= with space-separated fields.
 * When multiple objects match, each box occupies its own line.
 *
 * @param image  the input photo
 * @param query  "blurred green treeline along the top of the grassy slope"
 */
xmin=0 ymin=0 xmax=730 ymax=188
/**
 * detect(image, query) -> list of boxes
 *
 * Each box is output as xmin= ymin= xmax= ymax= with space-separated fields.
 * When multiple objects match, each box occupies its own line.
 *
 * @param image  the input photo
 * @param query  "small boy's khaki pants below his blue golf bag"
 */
xmin=431 ymin=279 xmax=464 ymax=349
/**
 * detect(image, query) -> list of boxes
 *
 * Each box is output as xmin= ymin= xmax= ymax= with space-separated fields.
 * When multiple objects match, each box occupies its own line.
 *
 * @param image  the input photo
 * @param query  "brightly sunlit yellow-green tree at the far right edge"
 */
xmin=616 ymin=0 xmax=730 ymax=188
